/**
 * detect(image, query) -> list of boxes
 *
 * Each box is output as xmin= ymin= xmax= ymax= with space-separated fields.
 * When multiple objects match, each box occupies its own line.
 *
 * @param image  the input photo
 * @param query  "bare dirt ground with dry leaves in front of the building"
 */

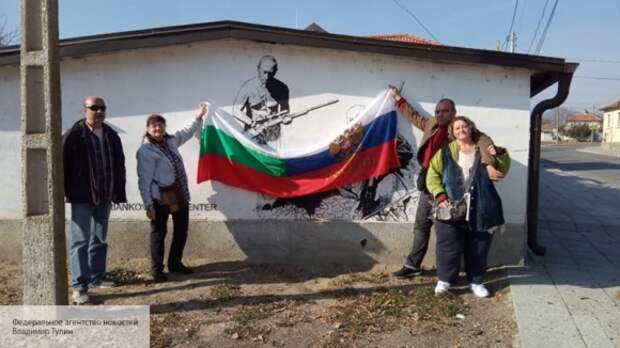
xmin=0 ymin=260 xmax=516 ymax=348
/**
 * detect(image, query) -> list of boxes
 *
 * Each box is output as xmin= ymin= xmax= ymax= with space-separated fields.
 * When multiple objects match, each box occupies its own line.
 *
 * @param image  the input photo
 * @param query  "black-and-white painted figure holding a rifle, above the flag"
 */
xmin=232 ymin=55 xmax=289 ymax=144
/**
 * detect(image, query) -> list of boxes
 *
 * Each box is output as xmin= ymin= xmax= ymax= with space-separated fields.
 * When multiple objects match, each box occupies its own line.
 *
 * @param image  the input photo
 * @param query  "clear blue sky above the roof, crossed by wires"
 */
xmin=0 ymin=0 xmax=620 ymax=110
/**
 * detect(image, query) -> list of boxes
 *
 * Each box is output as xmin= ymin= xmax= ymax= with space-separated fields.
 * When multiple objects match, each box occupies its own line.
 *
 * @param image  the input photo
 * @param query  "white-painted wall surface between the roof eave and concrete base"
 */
xmin=0 ymin=40 xmax=529 ymax=224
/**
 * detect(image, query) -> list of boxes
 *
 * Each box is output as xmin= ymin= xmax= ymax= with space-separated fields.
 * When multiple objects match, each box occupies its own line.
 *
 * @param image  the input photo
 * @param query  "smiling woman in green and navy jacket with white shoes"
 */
xmin=426 ymin=116 xmax=510 ymax=297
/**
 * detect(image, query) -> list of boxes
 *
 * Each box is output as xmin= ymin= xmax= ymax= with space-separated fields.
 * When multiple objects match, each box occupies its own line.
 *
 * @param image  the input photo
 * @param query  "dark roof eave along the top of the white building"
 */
xmin=0 ymin=21 xmax=576 ymax=95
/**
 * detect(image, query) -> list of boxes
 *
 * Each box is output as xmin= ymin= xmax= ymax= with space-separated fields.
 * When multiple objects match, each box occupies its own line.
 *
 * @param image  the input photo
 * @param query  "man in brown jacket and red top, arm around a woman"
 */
xmin=390 ymin=87 xmax=504 ymax=278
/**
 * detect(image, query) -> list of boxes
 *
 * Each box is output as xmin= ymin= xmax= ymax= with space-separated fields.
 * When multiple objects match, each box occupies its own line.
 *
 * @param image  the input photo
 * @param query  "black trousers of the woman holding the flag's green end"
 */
xmin=151 ymin=201 xmax=189 ymax=273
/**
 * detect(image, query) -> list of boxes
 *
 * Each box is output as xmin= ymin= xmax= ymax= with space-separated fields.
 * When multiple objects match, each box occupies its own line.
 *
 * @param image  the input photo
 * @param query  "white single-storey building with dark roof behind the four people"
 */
xmin=0 ymin=21 xmax=575 ymax=269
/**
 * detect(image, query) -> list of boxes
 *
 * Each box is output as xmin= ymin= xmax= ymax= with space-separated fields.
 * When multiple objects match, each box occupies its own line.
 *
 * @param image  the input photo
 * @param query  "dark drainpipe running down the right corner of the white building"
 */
xmin=527 ymin=70 xmax=577 ymax=256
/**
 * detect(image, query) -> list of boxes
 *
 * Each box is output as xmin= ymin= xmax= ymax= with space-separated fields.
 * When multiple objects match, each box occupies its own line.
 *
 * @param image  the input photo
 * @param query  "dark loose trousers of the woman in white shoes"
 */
xmin=435 ymin=221 xmax=493 ymax=284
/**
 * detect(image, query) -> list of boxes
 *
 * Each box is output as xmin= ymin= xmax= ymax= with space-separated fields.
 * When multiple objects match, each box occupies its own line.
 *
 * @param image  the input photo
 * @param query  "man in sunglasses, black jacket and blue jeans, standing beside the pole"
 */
xmin=63 ymin=97 xmax=127 ymax=304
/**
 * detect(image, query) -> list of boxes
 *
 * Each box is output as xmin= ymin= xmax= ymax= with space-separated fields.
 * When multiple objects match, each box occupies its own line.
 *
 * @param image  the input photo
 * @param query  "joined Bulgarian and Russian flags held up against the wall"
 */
xmin=197 ymin=91 xmax=400 ymax=198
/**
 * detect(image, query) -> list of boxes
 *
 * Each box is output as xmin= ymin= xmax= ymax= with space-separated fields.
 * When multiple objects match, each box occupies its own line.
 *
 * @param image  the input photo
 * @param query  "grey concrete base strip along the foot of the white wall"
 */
xmin=0 ymin=220 xmax=526 ymax=271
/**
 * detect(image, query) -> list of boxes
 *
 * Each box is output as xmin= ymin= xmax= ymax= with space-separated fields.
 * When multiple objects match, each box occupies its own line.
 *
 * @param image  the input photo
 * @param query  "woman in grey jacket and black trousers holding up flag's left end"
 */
xmin=137 ymin=104 xmax=207 ymax=282
